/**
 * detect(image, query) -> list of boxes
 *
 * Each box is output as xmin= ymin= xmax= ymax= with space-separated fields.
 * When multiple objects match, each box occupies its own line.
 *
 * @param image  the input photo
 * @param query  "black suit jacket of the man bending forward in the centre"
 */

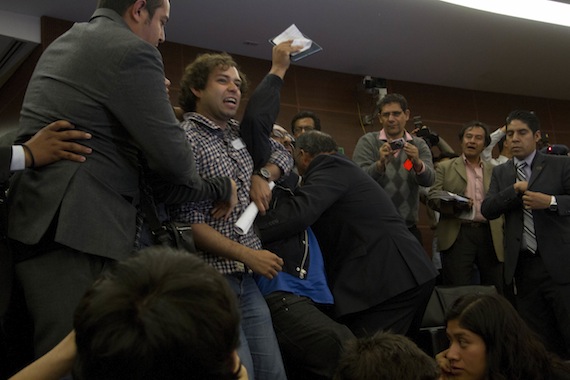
xmin=255 ymin=154 xmax=436 ymax=317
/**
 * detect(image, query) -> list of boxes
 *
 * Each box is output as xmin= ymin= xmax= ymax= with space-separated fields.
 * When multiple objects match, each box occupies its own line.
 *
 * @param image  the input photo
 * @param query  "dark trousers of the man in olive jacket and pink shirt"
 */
xmin=441 ymin=223 xmax=504 ymax=294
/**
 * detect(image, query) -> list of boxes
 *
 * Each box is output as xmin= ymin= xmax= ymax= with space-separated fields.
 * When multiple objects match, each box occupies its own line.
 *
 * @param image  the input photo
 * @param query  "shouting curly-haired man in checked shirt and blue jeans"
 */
xmin=169 ymin=42 xmax=295 ymax=380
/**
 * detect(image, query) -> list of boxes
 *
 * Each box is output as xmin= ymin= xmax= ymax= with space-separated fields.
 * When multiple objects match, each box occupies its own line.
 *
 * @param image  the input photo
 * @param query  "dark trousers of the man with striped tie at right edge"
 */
xmin=515 ymin=256 xmax=570 ymax=359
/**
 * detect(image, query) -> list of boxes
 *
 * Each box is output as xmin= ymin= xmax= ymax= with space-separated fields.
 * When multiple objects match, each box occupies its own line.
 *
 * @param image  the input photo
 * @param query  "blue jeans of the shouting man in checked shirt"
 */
xmin=225 ymin=273 xmax=287 ymax=380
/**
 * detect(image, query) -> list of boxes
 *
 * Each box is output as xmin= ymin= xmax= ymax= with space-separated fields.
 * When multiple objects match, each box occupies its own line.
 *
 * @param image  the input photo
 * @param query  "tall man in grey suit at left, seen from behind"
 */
xmin=8 ymin=0 xmax=236 ymax=355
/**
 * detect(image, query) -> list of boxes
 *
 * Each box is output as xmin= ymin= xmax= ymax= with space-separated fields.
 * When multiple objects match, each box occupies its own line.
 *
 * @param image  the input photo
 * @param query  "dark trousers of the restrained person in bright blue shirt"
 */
xmin=265 ymin=292 xmax=354 ymax=380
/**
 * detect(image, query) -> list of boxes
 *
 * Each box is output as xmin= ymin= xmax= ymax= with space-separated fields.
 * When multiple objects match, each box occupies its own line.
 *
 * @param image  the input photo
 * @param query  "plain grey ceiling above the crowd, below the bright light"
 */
xmin=0 ymin=0 xmax=570 ymax=100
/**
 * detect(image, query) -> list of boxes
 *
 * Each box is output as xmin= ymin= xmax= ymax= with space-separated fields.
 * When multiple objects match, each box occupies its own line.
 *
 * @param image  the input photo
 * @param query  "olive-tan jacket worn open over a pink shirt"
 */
xmin=428 ymin=156 xmax=504 ymax=261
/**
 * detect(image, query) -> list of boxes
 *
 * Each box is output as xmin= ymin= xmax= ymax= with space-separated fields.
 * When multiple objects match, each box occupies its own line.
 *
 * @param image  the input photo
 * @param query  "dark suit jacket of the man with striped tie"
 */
xmin=481 ymin=152 xmax=570 ymax=284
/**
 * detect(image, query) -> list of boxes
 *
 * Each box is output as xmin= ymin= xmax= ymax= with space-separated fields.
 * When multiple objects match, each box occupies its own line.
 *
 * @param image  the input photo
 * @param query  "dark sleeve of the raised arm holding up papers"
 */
xmin=240 ymin=74 xmax=283 ymax=169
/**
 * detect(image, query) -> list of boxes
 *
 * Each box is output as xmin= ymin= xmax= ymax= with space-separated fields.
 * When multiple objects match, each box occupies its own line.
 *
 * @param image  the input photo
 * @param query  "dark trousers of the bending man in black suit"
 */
xmin=339 ymin=279 xmax=435 ymax=340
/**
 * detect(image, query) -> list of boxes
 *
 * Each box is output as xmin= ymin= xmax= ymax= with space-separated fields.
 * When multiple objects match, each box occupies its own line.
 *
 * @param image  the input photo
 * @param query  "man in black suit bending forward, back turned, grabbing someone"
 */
xmin=259 ymin=131 xmax=437 ymax=336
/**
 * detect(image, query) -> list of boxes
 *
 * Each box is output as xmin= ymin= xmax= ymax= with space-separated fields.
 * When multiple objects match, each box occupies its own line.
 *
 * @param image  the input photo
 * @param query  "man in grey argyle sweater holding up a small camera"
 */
xmin=352 ymin=94 xmax=435 ymax=242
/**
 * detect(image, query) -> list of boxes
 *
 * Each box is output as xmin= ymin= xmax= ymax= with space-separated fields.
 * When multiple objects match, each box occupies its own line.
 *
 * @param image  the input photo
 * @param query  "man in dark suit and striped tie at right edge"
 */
xmin=481 ymin=111 xmax=570 ymax=358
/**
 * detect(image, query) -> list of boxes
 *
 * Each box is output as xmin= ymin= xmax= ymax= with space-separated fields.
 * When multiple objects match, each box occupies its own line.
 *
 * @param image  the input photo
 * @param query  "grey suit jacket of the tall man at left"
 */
xmin=8 ymin=9 xmax=230 ymax=259
